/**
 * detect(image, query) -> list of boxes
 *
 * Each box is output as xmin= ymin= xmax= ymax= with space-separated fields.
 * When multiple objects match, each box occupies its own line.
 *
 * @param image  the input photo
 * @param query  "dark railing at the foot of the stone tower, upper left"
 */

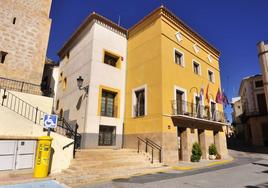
xmin=0 ymin=77 xmax=42 ymax=95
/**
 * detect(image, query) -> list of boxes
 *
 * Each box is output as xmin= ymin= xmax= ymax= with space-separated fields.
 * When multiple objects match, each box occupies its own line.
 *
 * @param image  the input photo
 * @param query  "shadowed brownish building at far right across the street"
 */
xmin=239 ymin=74 xmax=268 ymax=145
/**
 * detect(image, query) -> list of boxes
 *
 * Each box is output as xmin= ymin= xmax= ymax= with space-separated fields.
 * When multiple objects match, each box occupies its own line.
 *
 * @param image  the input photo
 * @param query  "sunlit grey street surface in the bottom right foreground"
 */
xmin=78 ymin=140 xmax=268 ymax=188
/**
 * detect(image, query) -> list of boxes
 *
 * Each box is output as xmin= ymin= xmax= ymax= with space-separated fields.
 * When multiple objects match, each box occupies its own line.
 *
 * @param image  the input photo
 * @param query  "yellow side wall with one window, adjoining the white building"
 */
xmin=124 ymin=20 xmax=162 ymax=135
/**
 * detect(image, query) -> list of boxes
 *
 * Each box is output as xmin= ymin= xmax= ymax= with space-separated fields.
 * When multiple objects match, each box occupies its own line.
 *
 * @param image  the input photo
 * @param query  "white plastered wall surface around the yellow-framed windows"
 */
xmin=57 ymin=21 xmax=127 ymax=148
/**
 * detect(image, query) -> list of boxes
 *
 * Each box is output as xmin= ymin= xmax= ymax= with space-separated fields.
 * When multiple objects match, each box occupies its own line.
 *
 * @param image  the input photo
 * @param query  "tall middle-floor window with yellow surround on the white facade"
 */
xmin=101 ymin=90 xmax=116 ymax=117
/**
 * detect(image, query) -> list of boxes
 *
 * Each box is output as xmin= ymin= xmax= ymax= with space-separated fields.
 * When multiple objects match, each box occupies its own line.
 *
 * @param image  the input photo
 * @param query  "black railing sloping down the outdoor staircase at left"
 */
xmin=0 ymin=89 xmax=81 ymax=158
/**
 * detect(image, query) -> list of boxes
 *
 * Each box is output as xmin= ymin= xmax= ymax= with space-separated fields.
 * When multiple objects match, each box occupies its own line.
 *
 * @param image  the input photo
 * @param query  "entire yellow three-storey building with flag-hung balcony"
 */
xmin=124 ymin=7 xmax=227 ymax=163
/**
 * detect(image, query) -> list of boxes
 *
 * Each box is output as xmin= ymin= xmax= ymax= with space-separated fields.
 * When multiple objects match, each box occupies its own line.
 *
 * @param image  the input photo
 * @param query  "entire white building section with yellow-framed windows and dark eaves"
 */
xmin=56 ymin=13 xmax=127 ymax=148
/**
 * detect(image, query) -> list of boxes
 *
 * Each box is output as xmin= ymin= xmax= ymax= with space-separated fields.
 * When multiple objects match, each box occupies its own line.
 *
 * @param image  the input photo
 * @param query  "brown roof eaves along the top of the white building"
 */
xmin=58 ymin=12 xmax=127 ymax=58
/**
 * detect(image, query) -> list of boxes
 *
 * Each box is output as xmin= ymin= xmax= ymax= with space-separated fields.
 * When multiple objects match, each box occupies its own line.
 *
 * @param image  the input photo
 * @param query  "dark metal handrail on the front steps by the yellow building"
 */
xmin=137 ymin=137 xmax=162 ymax=163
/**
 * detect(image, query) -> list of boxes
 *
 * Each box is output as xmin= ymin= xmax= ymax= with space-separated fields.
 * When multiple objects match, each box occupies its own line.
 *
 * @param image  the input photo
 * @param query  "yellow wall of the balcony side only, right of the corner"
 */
xmin=161 ymin=17 xmax=222 ymax=132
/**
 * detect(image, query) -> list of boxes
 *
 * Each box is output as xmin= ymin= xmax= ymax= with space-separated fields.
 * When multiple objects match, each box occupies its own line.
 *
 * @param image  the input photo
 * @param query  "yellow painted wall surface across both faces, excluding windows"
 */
xmin=125 ymin=10 xmax=222 ymax=135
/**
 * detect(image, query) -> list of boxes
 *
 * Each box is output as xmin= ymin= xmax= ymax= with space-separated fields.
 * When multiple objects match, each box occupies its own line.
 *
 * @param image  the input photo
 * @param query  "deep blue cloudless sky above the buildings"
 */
xmin=47 ymin=0 xmax=268 ymax=119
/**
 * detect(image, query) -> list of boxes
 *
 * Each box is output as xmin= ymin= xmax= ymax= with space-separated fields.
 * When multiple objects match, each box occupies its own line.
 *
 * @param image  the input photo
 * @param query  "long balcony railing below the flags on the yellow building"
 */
xmin=171 ymin=100 xmax=227 ymax=123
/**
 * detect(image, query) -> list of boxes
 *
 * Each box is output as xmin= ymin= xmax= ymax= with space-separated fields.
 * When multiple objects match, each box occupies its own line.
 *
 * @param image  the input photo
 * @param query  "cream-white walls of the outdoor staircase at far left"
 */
xmin=0 ymin=90 xmax=73 ymax=173
